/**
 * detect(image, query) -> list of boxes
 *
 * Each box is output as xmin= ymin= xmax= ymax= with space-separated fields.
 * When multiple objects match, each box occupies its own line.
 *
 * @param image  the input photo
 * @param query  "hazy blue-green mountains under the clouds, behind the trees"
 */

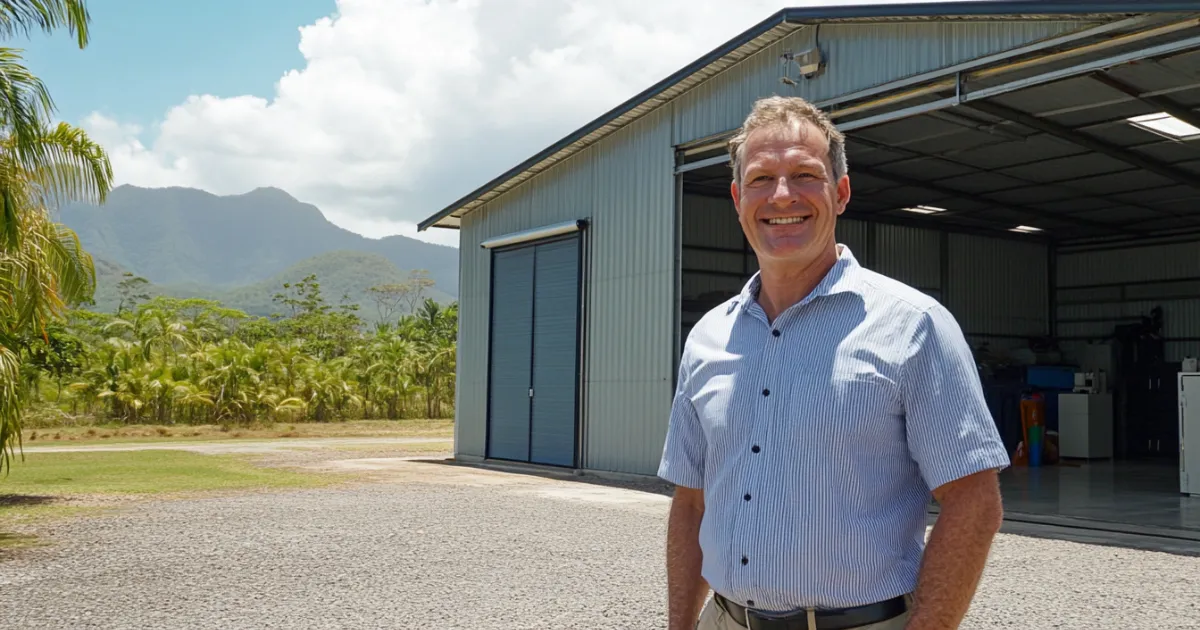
xmin=59 ymin=185 xmax=458 ymax=318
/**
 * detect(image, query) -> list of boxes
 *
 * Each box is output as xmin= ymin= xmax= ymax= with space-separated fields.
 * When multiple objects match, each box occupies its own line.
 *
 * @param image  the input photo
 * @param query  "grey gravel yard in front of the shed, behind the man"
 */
xmin=0 ymin=458 xmax=1200 ymax=630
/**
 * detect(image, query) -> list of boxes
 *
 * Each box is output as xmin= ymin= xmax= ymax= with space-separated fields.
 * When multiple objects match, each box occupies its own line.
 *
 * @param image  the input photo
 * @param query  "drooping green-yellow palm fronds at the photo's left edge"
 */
xmin=0 ymin=0 xmax=113 ymax=470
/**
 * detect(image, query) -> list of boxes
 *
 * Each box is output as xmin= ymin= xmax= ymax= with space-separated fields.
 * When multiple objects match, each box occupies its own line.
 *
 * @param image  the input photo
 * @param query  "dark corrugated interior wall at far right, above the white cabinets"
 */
xmin=1057 ymin=239 xmax=1200 ymax=361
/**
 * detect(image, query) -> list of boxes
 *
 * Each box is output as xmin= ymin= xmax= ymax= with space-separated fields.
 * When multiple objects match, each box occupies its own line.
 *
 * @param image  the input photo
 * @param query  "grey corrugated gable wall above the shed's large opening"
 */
xmin=676 ymin=17 xmax=1093 ymax=143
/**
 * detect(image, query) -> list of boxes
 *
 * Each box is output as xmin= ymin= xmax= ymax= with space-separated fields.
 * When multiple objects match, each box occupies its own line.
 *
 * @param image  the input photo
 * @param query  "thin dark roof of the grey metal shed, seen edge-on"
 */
xmin=418 ymin=0 xmax=1196 ymax=232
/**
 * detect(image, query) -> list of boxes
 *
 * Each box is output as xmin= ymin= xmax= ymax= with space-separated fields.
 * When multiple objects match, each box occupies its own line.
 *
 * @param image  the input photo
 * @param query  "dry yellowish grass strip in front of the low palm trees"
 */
xmin=21 ymin=419 xmax=454 ymax=446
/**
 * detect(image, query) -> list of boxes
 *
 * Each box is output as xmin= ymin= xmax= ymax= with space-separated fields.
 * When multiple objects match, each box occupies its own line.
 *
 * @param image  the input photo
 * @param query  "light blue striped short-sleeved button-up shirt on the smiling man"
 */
xmin=659 ymin=246 xmax=1009 ymax=612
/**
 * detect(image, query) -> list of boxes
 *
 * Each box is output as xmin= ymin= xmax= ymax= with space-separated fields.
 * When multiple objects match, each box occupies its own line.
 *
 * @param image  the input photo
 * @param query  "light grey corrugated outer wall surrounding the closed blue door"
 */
xmin=455 ymin=108 xmax=674 ymax=473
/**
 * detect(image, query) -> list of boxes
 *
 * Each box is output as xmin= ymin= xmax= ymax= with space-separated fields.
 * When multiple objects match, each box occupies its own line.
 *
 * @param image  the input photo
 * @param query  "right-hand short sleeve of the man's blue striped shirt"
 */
xmin=900 ymin=305 xmax=1010 ymax=490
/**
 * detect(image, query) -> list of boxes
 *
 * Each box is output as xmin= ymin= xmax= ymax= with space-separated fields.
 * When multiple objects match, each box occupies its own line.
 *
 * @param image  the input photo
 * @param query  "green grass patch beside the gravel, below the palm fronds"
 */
xmin=0 ymin=450 xmax=346 ymax=550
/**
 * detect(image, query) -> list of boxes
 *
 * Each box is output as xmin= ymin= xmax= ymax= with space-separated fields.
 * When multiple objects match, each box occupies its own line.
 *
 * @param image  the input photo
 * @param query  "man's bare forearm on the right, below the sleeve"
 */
xmin=906 ymin=470 xmax=1004 ymax=630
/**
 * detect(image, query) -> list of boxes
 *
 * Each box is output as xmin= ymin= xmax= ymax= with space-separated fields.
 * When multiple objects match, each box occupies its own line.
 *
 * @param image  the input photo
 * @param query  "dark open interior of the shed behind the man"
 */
xmin=679 ymin=23 xmax=1200 ymax=540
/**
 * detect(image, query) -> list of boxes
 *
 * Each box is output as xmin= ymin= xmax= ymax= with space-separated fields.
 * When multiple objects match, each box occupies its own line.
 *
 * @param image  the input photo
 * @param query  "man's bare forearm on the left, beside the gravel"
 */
xmin=667 ymin=486 xmax=708 ymax=630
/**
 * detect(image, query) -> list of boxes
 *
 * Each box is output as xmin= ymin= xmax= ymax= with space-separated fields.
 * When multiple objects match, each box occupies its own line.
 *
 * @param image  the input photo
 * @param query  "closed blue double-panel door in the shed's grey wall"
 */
xmin=488 ymin=236 xmax=580 ymax=466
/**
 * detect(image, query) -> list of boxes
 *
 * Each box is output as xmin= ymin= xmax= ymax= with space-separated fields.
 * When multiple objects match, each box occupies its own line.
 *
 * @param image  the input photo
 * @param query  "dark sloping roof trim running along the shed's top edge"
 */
xmin=418 ymin=0 xmax=1198 ymax=232
